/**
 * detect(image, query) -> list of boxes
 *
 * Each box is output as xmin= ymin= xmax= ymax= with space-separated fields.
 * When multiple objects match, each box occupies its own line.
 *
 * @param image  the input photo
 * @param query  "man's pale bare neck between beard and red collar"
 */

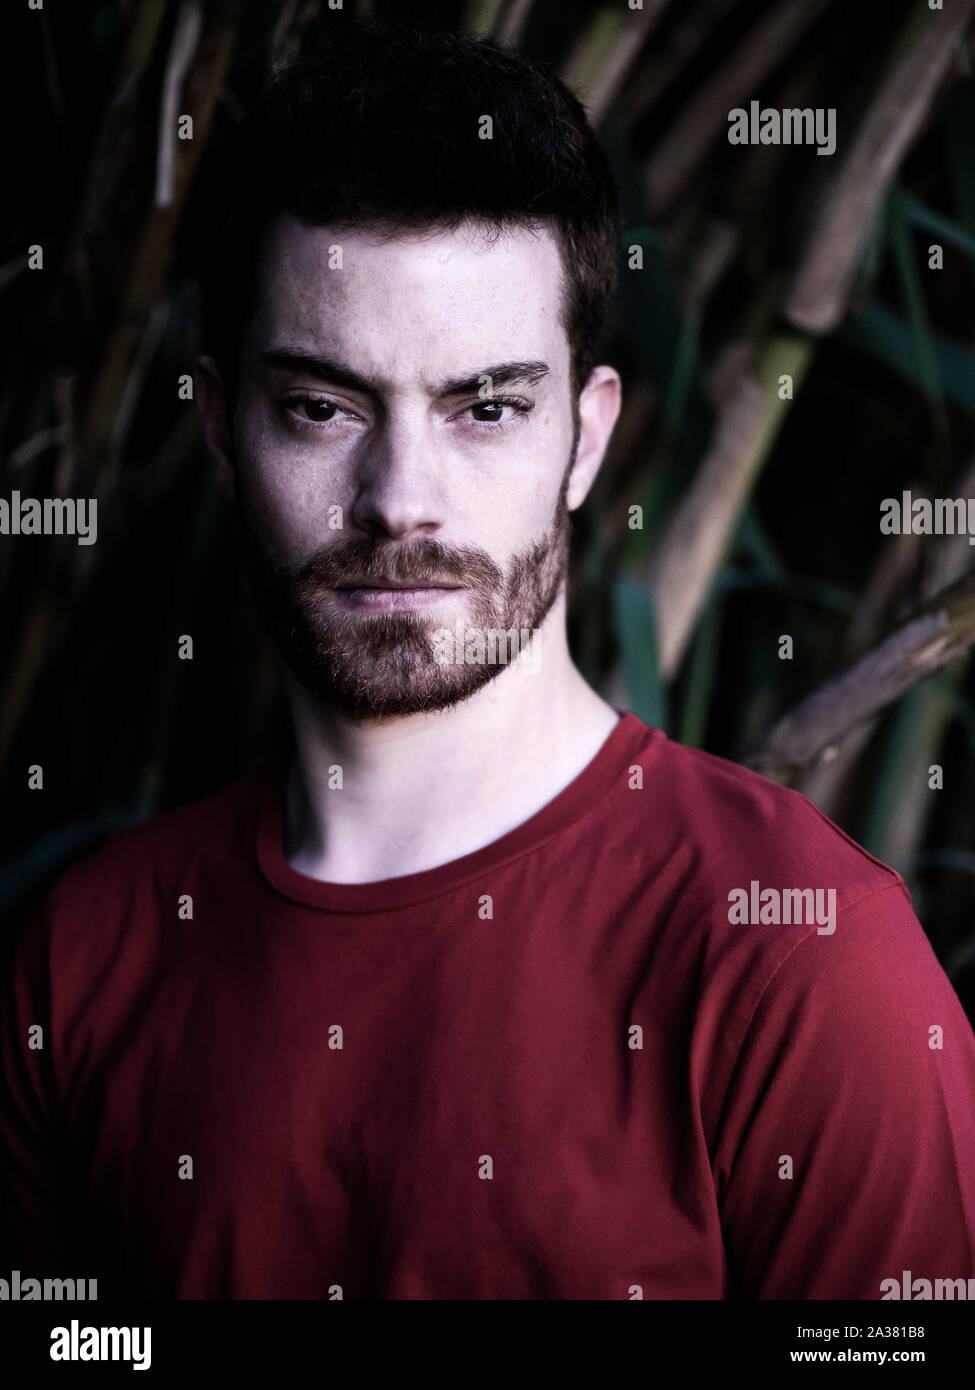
xmin=284 ymin=599 xmax=618 ymax=883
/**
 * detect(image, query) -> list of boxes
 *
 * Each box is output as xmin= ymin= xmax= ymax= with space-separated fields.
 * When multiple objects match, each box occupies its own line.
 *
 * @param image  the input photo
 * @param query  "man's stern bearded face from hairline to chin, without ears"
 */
xmin=223 ymin=217 xmax=581 ymax=720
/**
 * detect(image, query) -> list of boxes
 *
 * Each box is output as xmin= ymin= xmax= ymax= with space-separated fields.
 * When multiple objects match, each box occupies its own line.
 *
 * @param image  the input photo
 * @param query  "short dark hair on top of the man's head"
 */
xmin=199 ymin=22 xmax=622 ymax=400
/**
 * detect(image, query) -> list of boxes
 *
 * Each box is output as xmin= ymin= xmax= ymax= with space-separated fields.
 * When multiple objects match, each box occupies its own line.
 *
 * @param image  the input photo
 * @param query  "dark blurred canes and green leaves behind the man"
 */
xmin=0 ymin=0 xmax=975 ymax=1015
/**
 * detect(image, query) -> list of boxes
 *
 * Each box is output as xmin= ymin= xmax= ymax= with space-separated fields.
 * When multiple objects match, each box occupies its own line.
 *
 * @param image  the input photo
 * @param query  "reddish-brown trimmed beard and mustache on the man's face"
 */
xmin=236 ymin=450 xmax=579 ymax=720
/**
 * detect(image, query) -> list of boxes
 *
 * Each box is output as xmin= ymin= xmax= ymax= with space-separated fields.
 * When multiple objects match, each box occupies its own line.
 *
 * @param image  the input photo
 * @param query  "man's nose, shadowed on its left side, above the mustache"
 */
xmin=350 ymin=411 xmax=445 ymax=539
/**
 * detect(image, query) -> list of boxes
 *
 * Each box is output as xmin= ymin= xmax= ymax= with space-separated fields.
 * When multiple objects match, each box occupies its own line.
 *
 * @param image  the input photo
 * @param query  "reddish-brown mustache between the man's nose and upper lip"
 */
xmin=293 ymin=537 xmax=505 ymax=589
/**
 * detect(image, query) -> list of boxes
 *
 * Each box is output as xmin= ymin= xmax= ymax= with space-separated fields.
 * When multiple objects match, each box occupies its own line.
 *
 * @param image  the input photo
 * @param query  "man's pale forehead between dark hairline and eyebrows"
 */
xmin=252 ymin=215 xmax=569 ymax=384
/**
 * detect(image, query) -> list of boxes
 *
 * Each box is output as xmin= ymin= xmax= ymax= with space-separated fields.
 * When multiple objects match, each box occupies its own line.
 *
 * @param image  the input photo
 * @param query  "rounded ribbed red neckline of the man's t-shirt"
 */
xmin=257 ymin=709 xmax=663 ymax=913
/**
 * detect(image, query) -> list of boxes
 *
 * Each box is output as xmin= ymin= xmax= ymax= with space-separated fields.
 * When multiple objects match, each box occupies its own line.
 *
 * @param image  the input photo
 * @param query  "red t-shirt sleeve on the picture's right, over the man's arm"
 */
xmin=712 ymin=887 xmax=975 ymax=1300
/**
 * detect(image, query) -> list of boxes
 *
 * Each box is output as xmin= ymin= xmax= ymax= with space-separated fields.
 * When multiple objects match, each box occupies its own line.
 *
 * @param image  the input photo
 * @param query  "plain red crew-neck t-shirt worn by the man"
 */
xmin=1 ymin=714 xmax=975 ymax=1300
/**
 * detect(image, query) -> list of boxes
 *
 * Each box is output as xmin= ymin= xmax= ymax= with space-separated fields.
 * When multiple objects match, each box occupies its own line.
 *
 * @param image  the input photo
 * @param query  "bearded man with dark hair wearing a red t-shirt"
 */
xmin=3 ymin=28 xmax=975 ymax=1300
